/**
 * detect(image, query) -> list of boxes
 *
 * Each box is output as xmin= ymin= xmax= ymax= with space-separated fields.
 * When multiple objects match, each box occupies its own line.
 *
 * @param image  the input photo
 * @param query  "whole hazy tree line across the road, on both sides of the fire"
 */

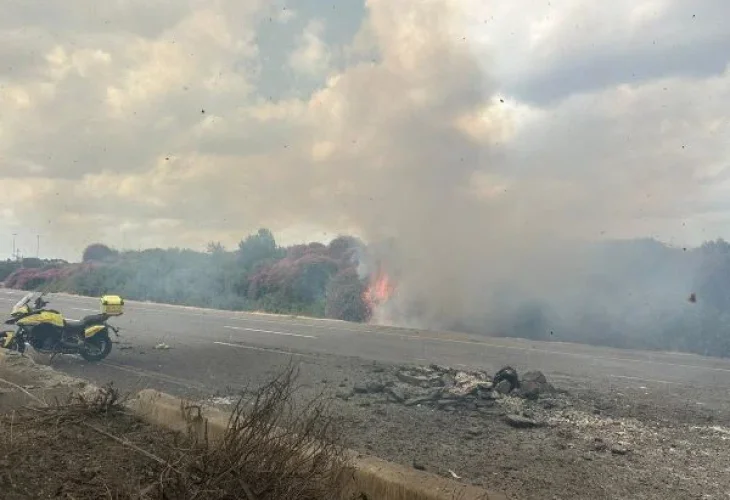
xmin=0 ymin=229 xmax=730 ymax=357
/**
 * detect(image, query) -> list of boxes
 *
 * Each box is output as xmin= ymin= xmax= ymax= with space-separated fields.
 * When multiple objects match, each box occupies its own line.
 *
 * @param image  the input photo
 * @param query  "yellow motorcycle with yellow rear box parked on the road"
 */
xmin=0 ymin=292 xmax=124 ymax=361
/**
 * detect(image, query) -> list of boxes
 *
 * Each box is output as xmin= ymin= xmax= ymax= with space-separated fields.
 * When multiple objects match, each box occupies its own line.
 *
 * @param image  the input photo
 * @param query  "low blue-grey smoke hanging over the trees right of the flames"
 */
xmin=364 ymin=240 xmax=704 ymax=350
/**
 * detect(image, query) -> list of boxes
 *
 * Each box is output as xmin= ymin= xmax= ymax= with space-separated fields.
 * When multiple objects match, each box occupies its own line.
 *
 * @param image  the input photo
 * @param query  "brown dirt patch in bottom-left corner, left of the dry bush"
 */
xmin=0 ymin=410 xmax=185 ymax=500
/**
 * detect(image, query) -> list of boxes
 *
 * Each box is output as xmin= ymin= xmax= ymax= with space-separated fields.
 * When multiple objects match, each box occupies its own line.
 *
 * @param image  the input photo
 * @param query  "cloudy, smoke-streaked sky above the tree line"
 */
xmin=0 ymin=0 xmax=730 ymax=264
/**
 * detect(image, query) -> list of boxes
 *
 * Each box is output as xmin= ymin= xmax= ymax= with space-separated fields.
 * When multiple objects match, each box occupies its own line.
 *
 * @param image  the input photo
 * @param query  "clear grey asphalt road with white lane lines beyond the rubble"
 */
xmin=0 ymin=289 xmax=730 ymax=398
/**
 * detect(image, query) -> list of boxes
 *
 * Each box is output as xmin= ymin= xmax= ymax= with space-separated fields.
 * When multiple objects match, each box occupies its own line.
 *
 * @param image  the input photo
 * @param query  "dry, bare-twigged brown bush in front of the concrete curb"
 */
xmin=155 ymin=365 xmax=347 ymax=500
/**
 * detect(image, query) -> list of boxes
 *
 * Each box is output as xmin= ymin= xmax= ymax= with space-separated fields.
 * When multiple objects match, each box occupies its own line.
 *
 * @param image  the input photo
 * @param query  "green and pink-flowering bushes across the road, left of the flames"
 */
xmin=0 ymin=228 xmax=370 ymax=321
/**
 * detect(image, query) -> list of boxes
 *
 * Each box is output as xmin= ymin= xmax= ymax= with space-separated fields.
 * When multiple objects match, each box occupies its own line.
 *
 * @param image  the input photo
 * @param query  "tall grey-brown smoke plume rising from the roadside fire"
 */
xmin=331 ymin=2 xmax=708 ymax=342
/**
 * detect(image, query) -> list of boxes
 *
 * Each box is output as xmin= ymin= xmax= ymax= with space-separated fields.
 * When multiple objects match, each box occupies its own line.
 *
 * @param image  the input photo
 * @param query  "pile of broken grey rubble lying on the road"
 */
xmin=338 ymin=365 xmax=555 ymax=414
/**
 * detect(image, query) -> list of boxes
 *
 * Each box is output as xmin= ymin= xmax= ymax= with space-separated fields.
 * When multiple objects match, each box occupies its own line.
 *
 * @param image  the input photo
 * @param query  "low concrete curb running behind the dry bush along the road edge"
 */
xmin=128 ymin=389 xmax=507 ymax=500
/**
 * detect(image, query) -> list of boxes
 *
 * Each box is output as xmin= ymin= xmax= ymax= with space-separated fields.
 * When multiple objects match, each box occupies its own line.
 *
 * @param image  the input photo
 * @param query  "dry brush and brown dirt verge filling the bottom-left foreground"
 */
xmin=0 ymin=366 xmax=349 ymax=500
